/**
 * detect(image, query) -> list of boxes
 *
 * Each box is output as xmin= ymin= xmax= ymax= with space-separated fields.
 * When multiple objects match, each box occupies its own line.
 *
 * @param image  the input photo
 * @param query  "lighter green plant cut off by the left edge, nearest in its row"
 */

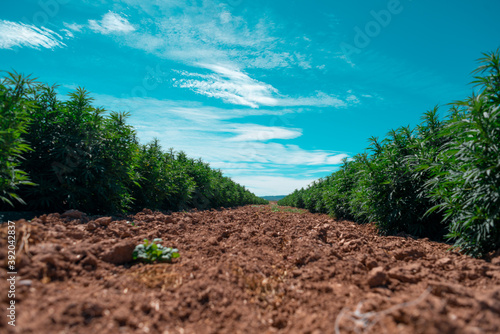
xmin=0 ymin=73 xmax=34 ymax=206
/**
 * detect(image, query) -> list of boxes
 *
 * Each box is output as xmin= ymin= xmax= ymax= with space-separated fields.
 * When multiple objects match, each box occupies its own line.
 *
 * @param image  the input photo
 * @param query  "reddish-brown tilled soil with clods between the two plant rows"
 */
xmin=0 ymin=206 xmax=500 ymax=334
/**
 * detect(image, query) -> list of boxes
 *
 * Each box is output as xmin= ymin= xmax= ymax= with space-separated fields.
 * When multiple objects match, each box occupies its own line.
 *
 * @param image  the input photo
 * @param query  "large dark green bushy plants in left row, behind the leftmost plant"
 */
xmin=13 ymin=84 xmax=138 ymax=213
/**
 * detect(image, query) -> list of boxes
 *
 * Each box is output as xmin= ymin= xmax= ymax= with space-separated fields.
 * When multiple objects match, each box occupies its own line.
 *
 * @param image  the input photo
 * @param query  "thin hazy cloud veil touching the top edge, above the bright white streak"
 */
xmin=119 ymin=0 xmax=312 ymax=69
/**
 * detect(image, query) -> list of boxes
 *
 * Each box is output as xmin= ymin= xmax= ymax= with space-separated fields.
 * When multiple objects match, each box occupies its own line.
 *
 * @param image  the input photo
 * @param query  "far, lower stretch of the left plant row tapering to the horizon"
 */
xmin=133 ymin=139 xmax=267 ymax=210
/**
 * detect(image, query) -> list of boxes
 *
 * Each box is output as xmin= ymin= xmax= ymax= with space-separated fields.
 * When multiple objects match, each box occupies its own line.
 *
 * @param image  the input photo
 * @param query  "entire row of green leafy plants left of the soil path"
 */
xmin=0 ymin=73 xmax=267 ymax=213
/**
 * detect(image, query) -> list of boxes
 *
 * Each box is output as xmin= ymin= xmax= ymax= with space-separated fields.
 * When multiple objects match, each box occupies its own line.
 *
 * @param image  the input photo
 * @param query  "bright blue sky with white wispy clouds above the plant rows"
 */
xmin=0 ymin=0 xmax=500 ymax=195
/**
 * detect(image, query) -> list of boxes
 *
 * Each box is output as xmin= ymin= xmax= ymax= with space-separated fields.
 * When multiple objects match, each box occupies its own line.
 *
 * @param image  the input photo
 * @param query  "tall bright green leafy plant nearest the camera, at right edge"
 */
xmin=429 ymin=51 xmax=500 ymax=256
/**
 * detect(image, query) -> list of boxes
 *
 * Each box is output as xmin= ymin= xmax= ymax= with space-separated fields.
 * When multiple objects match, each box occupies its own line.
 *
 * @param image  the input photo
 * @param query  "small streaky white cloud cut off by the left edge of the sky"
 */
xmin=0 ymin=20 xmax=65 ymax=49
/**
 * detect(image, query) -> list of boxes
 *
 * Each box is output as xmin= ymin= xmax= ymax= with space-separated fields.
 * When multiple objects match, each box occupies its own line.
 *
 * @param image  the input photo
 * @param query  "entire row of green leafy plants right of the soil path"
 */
xmin=278 ymin=50 xmax=500 ymax=256
